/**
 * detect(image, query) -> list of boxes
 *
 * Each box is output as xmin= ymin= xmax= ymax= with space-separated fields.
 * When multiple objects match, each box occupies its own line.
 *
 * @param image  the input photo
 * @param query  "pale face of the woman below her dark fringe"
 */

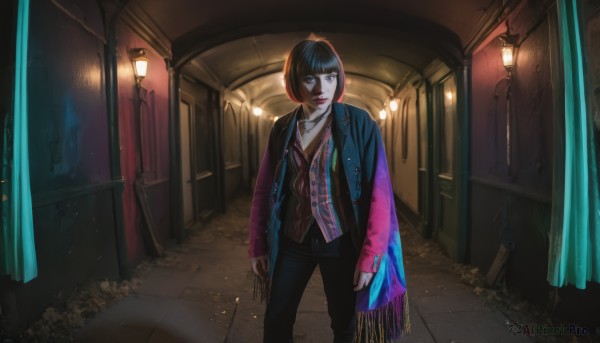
xmin=300 ymin=72 xmax=337 ymax=112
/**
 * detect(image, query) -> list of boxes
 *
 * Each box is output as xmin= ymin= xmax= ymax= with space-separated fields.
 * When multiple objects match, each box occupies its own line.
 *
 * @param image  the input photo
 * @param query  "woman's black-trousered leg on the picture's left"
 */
xmin=264 ymin=237 xmax=317 ymax=343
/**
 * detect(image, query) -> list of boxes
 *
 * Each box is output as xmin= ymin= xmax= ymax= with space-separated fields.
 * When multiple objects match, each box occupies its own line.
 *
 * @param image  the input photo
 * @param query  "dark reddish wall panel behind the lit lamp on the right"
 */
xmin=469 ymin=2 xmax=554 ymax=303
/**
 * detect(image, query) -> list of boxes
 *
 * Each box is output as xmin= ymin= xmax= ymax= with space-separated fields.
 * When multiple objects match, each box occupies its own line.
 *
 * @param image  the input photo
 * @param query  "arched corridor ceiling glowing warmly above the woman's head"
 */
xmin=126 ymin=0 xmax=519 ymax=114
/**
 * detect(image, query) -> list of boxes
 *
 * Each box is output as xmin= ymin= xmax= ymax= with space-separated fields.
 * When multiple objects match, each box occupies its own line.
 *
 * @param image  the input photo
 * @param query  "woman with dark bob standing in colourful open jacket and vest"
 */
xmin=249 ymin=37 xmax=409 ymax=343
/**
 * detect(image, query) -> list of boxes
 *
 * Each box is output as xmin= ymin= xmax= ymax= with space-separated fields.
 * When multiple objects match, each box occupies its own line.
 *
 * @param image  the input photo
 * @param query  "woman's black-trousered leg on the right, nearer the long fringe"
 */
xmin=319 ymin=235 xmax=356 ymax=343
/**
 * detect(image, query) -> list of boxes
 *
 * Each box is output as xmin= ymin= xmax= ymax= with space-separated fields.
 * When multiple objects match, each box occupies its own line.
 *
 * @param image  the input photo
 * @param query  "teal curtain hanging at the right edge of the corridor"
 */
xmin=548 ymin=0 xmax=600 ymax=289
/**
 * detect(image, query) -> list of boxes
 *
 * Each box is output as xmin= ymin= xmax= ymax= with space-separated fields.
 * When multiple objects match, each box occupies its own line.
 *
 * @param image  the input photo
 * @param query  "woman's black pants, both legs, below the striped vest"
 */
xmin=264 ymin=224 xmax=356 ymax=343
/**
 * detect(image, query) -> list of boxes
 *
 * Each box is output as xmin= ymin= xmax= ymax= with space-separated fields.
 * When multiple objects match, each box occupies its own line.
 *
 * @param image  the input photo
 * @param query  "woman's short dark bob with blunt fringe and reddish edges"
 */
xmin=283 ymin=35 xmax=346 ymax=102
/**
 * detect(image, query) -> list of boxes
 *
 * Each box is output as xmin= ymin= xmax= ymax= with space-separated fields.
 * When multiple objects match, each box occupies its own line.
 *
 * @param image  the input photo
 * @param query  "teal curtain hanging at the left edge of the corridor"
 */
xmin=0 ymin=0 xmax=37 ymax=282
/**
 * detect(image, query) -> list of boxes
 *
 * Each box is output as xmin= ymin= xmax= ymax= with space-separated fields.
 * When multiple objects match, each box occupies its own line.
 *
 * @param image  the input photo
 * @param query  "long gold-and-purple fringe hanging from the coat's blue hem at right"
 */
xmin=356 ymin=293 xmax=410 ymax=343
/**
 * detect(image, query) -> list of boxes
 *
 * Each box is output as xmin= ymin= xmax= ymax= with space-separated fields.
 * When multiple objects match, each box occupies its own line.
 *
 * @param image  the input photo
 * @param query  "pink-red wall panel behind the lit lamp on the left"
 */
xmin=117 ymin=24 xmax=170 ymax=264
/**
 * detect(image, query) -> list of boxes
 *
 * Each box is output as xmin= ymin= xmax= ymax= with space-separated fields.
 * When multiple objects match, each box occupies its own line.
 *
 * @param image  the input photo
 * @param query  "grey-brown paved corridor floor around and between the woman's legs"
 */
xmin=76 ymin=196 xmax=531 ymax=343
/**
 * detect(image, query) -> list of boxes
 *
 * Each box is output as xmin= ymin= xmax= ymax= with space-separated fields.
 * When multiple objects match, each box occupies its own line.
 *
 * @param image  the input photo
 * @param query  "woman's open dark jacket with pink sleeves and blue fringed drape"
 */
xmin=249 ymin=103 xmax=409 ymax=341
